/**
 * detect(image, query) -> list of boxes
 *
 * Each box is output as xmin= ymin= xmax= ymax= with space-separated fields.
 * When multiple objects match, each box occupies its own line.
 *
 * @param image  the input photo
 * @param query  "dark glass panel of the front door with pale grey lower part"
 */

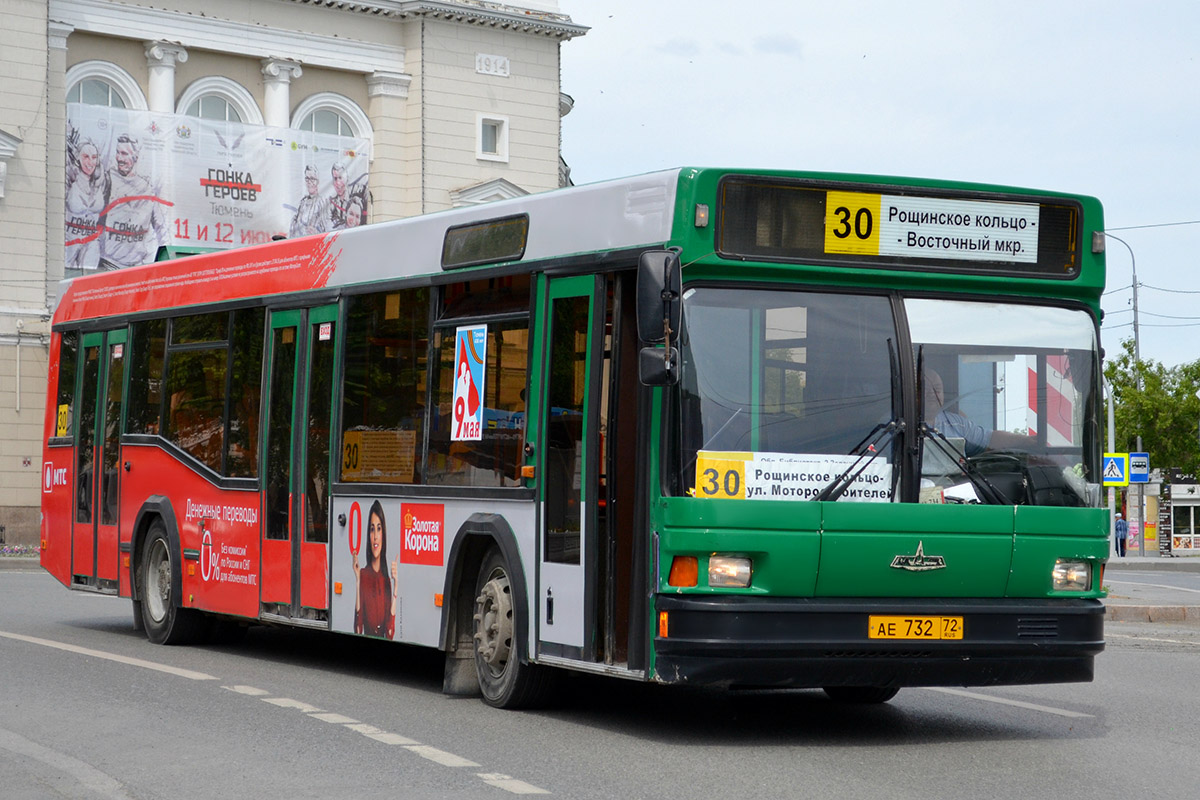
xmin=546 ymin=297 xmax=588 ymax=564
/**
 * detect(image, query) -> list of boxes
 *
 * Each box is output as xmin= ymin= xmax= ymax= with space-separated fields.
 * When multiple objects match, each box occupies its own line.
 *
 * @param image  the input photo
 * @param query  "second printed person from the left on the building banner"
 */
xmin=100 ymin=133 xmax=169 ymax=269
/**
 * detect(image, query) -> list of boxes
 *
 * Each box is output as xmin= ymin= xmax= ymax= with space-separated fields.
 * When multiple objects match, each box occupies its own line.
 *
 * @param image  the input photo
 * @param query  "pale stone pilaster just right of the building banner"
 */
xmin=367 ymin=72 xmax=412 ymax=222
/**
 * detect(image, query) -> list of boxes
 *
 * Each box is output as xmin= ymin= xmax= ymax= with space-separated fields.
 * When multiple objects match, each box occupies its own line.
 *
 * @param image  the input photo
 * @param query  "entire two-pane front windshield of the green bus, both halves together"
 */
xmin=680 ymin=288 xmax=1099 ymax=506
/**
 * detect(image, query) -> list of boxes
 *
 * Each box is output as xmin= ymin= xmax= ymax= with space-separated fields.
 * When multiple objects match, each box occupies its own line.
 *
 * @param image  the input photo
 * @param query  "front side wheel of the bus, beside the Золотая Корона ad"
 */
xmin=473 ymin=547 xmax=552 ymax=709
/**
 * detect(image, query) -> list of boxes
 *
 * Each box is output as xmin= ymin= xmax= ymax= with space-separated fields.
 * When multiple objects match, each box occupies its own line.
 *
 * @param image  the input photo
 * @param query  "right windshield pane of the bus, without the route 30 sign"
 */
xmin=905 ymin=299 xmax=1099 ymax=506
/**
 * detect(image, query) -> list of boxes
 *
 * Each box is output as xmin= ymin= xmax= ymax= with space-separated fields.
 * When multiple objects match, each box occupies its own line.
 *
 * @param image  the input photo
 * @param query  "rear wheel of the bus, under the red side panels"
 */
xmin=134 ymin=519 xmax=205 ymax=644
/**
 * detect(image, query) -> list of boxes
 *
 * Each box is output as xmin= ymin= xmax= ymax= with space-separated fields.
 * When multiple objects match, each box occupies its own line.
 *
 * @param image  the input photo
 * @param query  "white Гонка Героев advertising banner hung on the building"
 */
xmin=65 ymin=103 xmax=368 ymax=269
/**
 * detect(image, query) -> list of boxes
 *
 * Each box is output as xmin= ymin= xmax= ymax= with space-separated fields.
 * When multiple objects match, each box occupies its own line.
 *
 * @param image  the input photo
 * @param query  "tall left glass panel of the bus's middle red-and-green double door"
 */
xmin=266 ymin=327 xmax=296 ymax=540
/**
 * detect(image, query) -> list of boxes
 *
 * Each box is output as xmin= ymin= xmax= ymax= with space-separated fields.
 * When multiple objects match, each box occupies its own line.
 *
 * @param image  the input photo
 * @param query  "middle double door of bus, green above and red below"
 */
xmin=260 ymin=306 xmax=338 ymax=627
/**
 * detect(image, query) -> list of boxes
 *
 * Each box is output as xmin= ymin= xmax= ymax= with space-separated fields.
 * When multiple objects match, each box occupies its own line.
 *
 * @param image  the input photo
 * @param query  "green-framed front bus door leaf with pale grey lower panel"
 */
xmin=538 ymin=276 xmax=604 ymax=660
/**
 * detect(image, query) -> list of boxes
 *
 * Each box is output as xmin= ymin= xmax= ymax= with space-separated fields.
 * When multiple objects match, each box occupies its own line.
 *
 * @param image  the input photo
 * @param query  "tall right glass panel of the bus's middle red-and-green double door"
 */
xmin=305 ymin=323 xmax=334 ymax=542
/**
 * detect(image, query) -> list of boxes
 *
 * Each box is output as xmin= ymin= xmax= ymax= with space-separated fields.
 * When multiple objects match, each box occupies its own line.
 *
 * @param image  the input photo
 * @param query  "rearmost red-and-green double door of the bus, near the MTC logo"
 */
xmin=71 ymin=329 xmax=127 ymax=594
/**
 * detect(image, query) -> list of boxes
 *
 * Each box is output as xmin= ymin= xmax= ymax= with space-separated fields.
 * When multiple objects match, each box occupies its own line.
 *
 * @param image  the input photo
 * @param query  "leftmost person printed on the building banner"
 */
xmin=65 ymin=128 xmax=108 ymax=270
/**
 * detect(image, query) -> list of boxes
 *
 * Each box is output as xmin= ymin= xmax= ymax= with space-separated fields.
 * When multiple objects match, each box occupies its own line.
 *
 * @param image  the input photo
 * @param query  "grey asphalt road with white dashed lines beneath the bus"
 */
xmin=0 ymin=570 xmax=1200 ymax=800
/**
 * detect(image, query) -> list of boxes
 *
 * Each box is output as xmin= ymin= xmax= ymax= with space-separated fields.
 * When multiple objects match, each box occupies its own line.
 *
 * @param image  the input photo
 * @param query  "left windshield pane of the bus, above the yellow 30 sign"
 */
xmin=682 ymin=288 xmax=899 ymax=500
